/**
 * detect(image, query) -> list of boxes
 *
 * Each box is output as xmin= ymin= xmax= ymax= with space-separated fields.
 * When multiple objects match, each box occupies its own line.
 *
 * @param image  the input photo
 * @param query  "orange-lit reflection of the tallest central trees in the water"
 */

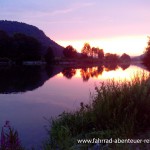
xmin=80 ymin=66 xmax=103 ymax=81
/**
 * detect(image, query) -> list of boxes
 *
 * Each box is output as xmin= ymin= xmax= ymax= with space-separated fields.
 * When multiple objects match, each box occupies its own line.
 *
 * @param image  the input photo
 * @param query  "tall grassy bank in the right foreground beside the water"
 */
xmin=44 ymin=74 xmax=150 ymax=150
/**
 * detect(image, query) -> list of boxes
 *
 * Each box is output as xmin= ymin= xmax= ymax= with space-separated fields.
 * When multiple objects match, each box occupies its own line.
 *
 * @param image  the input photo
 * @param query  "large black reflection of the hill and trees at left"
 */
xmin=0 ymin=65 xmax=56 ymax=94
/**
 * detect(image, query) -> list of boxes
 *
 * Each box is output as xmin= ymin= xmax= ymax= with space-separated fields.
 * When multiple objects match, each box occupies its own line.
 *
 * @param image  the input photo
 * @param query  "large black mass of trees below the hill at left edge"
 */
xmin=0 ymin=31 xmax=41 ymax=62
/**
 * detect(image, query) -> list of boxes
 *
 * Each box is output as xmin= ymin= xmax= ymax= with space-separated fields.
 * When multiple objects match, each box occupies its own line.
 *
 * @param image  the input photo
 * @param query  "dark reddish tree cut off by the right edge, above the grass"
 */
xmin=143 ymin=37 xmax=150 ymax=68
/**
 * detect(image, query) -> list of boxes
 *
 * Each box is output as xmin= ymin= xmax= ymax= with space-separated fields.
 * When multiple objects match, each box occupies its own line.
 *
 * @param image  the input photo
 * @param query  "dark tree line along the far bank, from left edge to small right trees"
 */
xmin=0 ymin=30 xmax=130 ymax=64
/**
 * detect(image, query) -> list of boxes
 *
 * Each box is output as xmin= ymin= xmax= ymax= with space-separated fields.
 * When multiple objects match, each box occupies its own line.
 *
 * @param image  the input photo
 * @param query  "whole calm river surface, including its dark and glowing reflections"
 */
xmin=0 ymin=65 xmax=147 ymax=149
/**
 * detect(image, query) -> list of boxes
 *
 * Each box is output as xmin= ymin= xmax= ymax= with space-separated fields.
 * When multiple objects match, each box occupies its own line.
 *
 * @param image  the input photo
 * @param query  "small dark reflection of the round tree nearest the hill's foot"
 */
xmin=62 ymin=67 xmax=76 ymax=79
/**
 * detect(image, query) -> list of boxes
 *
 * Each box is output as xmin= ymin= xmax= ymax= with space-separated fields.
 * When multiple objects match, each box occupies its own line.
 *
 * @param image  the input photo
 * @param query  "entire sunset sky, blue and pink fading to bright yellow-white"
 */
xmin=0 ymin=0 xmax=150 ymax=55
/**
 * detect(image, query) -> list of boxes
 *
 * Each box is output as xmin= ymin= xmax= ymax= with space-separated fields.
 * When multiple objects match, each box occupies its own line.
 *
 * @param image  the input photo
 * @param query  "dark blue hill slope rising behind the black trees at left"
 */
xmin=0 ymin=20 xmax=63 ymax=57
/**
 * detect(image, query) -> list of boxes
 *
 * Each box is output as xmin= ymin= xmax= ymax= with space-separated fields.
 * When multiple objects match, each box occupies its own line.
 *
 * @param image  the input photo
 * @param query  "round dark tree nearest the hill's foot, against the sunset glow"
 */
xmin=63 ymin=45 xmax=77 ymax=58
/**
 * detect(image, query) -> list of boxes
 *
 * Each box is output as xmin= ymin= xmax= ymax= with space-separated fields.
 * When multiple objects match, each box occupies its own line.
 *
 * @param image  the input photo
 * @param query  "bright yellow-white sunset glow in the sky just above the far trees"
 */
xmin=57 ymin=35 xmax=148 ymax=56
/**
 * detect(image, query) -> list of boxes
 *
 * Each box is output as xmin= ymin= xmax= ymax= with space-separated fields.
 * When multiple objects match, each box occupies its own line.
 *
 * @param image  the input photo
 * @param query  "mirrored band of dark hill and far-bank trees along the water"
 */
xmin=0 ymin=63 xmax=148 ymax=94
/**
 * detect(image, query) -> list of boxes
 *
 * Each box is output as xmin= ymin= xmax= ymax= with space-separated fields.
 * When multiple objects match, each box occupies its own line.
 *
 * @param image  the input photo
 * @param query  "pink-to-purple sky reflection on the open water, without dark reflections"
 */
xmin=0 ymin=66 xmax=148 ymax=149
